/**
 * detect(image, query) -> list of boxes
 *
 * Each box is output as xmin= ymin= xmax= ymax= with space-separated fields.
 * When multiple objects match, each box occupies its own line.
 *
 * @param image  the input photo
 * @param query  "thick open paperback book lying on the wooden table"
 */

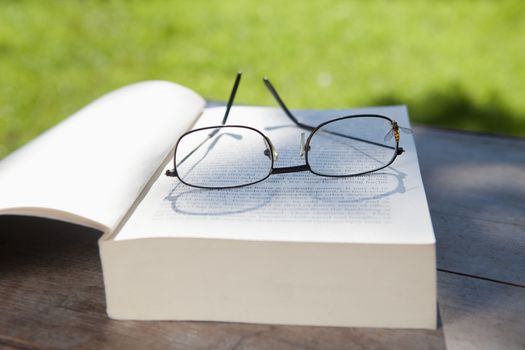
xmin=0 ymin=81 xmax=436 ymax=328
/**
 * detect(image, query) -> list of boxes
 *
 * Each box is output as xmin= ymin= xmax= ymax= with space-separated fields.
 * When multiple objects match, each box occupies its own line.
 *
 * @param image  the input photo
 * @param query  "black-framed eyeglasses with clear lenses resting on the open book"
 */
xmin=166 ymin=73 xmax=412 ymax=189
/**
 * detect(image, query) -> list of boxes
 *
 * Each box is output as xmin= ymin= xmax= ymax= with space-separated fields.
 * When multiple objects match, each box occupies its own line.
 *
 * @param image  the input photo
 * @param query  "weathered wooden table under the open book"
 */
xmin=0 ymin=127 xmax=525 ymax=349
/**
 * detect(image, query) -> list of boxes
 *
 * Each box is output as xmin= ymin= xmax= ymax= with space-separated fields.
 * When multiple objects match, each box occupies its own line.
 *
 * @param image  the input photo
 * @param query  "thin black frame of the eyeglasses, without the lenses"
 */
xmin=165 ymin=73 xmax=404 ymax=189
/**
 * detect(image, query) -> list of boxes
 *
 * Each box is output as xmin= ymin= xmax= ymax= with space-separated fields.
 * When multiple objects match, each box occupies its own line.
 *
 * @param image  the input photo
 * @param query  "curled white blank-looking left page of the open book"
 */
xmin=0 ymin=81 xmax=205 ymax=229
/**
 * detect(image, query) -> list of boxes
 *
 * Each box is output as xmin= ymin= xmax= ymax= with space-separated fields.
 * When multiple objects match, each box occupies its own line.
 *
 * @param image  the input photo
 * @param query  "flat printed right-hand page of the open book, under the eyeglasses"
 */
xmin=115 ymin=106 xmax=434 ymax=244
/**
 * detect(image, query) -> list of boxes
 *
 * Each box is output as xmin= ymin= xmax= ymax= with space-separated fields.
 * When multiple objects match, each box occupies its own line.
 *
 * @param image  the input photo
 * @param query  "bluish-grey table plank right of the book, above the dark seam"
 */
xmin=415 ymin=127 xmax=525 ymax=286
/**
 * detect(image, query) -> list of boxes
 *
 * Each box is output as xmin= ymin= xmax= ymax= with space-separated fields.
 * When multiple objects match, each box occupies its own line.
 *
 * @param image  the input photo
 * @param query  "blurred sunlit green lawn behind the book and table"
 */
xmin=0 ymin=0 xmax=525 ymax=158
